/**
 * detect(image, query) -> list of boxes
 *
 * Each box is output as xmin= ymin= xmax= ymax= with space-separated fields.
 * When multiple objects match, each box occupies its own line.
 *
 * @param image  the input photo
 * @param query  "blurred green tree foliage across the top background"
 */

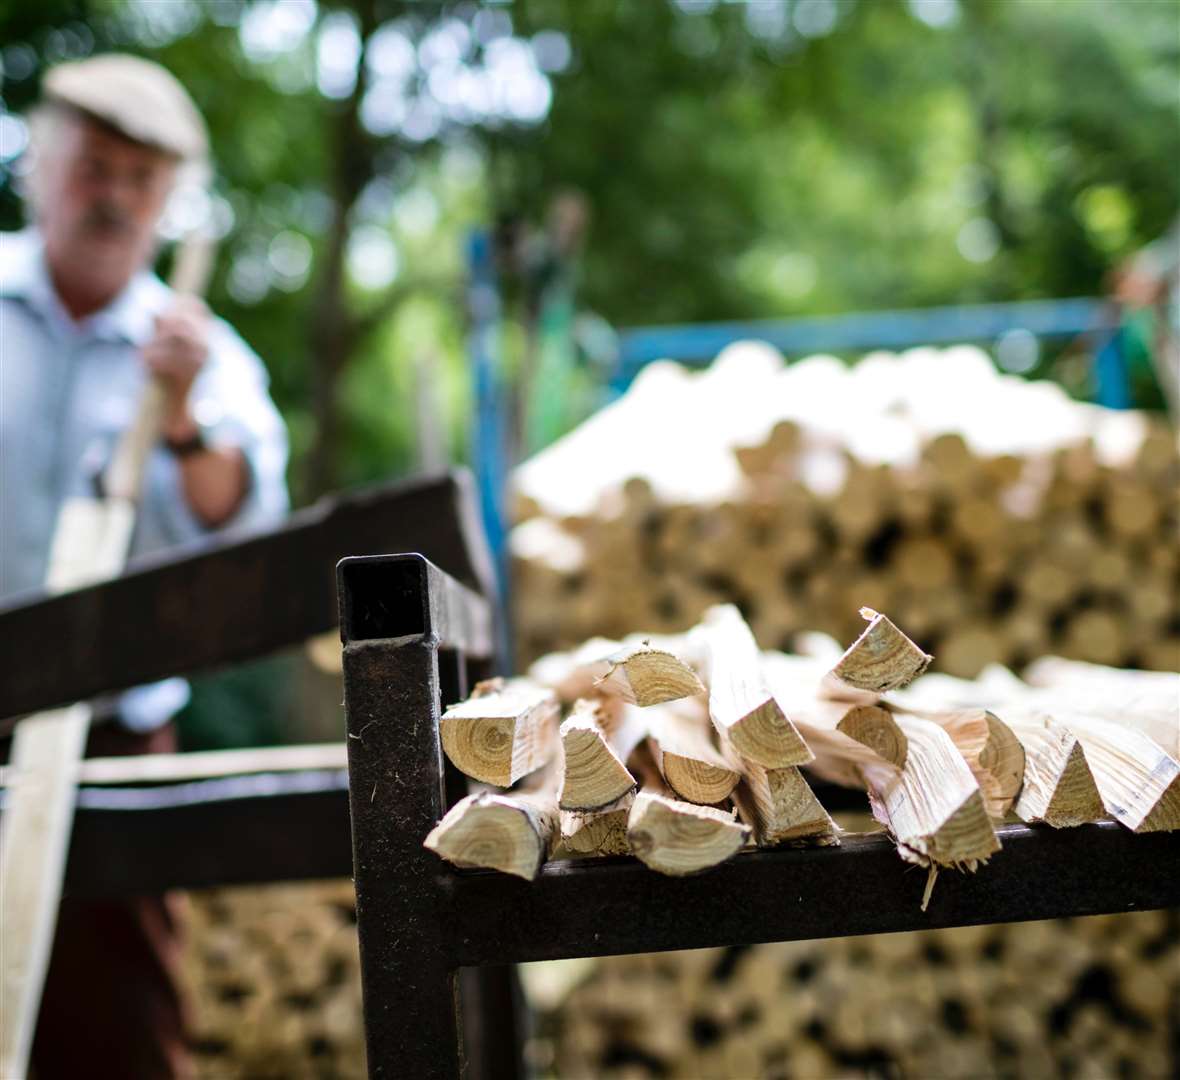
xmin=0 ymin=0 xmax=1180 ymax=497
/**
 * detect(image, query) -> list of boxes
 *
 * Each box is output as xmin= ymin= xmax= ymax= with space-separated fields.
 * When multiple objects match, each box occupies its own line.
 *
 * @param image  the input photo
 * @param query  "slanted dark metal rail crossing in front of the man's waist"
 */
xmin=0 ymin=472 xmax=494 ymax=716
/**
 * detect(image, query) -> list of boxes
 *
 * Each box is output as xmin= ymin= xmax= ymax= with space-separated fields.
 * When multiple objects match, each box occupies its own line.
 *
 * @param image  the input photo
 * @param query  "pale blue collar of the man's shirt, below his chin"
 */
xmin=0 ymin=229 xmax=171 ymax=346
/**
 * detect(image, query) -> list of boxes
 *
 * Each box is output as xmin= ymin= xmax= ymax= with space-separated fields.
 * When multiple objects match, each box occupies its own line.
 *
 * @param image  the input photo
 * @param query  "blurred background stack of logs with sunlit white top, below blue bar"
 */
xmin=511 ymin=343 xmax=1180 ymax=678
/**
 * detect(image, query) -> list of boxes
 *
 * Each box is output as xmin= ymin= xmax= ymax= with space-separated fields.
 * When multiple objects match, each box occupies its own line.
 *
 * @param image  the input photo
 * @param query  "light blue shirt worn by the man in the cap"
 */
xmin=0 ymin=229 xmax=288 ymax=731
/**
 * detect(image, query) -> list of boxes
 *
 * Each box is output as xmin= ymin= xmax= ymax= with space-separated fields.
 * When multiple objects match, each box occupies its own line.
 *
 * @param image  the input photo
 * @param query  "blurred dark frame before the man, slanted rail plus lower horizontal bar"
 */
xmin=0 ymin=471 xmax=494 ymax=897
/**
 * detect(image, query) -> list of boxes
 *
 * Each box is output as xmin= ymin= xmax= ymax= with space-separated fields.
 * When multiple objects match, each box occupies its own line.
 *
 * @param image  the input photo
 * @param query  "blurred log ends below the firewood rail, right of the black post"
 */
xmin=523 ymin=911 xmax=1180 ymax=1080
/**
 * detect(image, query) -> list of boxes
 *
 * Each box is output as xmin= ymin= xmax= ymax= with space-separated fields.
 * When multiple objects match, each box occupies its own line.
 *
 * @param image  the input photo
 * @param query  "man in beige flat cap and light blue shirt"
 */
xmin=0 ymin=55 xmax=287 ymax=1080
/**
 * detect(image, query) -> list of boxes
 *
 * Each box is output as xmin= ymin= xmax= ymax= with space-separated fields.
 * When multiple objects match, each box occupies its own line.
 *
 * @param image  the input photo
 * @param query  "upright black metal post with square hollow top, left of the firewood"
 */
xmin=337 ymin=556 xmax=486 ymax=1080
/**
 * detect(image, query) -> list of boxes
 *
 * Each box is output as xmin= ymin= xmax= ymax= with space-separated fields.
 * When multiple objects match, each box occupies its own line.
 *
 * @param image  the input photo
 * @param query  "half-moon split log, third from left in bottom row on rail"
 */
xmin=627 ymin=784 xmax=750 ymax=877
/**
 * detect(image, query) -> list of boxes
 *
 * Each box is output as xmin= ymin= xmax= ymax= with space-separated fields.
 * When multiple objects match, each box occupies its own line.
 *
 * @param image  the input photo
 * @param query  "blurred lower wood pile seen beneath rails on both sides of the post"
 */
xmin=176 ymin=882 xmax=1180 ymax=1080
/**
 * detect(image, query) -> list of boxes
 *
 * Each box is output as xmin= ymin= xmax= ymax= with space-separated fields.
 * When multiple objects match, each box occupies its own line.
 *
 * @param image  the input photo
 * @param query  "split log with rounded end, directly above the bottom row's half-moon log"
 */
xmin=643 ymin=698 xmax=739 ymax=804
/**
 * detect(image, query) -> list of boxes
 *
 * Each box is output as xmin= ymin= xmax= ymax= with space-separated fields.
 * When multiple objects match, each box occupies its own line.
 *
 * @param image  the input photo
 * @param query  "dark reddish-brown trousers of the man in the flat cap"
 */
xmin=0 ymin=721 xmax=191 ymax=1080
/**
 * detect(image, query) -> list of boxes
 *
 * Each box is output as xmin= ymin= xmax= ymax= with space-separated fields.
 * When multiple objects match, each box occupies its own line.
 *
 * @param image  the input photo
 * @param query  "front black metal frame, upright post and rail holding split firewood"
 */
xmin=337 ymin=555 xmax=1180 ymax=1080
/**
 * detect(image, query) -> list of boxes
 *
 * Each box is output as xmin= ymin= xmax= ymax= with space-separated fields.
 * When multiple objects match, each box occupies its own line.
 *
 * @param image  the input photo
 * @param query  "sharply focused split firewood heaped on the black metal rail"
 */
xmin=425 ymin=606 xmax=1180 ymax=892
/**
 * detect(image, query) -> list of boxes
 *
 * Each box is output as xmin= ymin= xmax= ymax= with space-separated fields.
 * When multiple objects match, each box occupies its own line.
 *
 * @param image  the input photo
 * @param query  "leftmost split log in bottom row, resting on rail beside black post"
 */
xmin=425 ymin=787 xmax=561 ymax=881
